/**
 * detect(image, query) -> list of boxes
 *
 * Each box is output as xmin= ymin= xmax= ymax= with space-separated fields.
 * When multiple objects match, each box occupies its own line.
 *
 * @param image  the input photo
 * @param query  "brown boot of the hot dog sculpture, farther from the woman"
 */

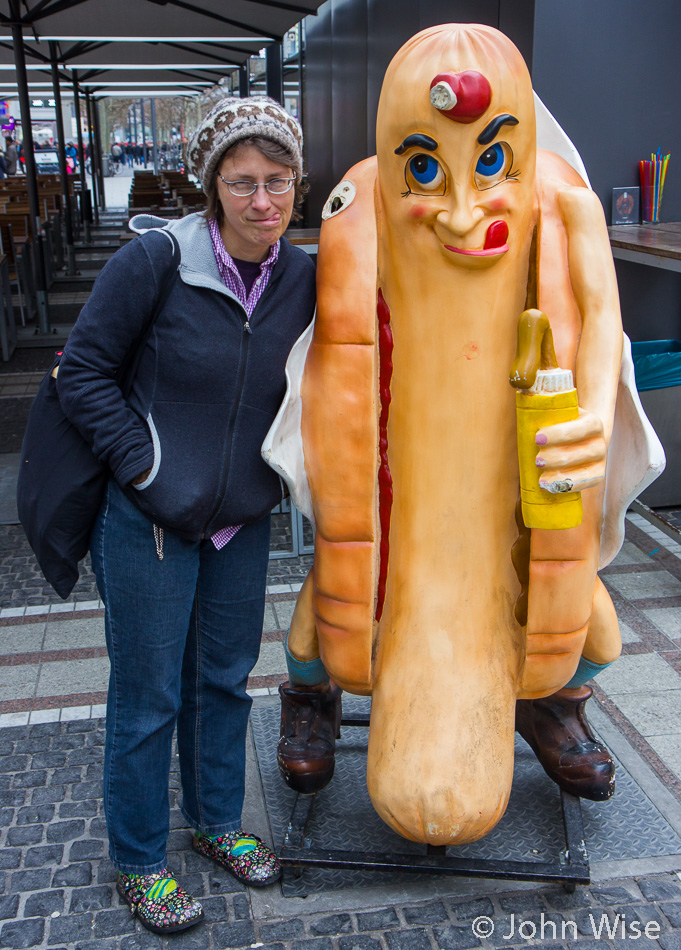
xmin=515 ymin=686 xmax=615 ymax=802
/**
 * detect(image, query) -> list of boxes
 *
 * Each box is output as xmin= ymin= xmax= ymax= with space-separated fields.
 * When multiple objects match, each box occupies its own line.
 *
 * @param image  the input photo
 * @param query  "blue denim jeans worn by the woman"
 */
xmin=90 ymin=481 xmax=270 ymax=874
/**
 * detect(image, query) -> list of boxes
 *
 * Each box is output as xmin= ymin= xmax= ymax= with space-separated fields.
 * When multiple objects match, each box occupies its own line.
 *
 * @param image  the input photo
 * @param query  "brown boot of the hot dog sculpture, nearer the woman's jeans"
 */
xmin=277 ymin=682 xmax=343 ymax=795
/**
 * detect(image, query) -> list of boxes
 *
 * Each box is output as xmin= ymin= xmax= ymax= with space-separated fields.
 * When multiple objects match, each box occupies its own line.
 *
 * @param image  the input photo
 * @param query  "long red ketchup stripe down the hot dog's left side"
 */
xmin=376 ymin=290 xmax=393 ymax=621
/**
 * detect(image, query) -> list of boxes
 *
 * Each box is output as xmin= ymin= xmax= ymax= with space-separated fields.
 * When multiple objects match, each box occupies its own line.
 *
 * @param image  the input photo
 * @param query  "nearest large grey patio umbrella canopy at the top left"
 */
xmin=0 ymin=0 xmax=320 ymax=96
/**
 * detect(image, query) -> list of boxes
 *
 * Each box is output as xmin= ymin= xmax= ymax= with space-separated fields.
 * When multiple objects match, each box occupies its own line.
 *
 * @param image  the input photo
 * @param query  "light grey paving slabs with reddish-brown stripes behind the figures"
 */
xmin=0 ymin=513 xmax=681 ymax=801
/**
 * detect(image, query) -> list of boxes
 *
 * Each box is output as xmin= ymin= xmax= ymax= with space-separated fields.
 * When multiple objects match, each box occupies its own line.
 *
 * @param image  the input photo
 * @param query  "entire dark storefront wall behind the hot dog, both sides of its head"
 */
xmin=305 ymin=0 xmax=681 ymax=340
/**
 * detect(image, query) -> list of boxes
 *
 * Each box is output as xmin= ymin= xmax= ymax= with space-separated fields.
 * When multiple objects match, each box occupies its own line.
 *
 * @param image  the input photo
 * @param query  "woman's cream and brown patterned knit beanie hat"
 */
xmin=187 ymin=96 xmax=303 ymax=194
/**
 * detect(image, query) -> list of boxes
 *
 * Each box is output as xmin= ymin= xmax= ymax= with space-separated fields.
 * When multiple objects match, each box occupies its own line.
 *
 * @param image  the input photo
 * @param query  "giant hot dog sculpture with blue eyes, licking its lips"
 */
xmin=264 ymin=25 xmax=654 ymax=845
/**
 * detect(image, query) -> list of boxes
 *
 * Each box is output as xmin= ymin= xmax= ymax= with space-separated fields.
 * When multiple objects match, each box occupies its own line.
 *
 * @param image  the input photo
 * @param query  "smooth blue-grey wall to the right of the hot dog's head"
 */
xmin=532 ymin=0 xmax=681 ymax=340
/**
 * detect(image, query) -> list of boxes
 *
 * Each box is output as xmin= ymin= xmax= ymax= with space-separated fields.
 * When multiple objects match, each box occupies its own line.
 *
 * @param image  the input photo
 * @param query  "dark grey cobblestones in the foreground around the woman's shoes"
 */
xmin=0 ymin=720 xmax=681 ymax=950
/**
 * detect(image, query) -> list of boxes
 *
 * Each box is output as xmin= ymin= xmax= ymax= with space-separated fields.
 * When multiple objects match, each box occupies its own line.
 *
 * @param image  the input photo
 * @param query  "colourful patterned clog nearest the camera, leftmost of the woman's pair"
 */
xmin=116 ymin=868 xmax=203 ymax=934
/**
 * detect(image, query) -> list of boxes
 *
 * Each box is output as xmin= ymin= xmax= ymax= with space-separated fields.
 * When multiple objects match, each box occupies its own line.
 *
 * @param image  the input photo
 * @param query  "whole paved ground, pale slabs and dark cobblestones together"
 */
xmin=0 ymin=514 xmax=681 ymax=950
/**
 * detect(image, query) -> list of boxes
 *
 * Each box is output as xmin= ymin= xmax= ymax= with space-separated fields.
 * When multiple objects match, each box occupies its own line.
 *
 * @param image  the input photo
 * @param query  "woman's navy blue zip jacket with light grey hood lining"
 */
xmin=57 ymin=214 xmax=315 ymax=540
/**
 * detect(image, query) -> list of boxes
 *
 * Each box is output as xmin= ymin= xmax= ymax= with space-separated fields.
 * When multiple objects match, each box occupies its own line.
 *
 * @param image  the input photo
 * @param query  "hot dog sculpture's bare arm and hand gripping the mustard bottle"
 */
xmin=536 ymin=187 xmax=622 ymax=490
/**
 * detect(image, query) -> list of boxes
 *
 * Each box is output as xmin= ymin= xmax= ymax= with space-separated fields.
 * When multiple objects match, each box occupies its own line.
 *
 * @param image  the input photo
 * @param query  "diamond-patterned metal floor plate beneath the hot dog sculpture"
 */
xmin=251 ymin=694 xmax=681 ymax=897
